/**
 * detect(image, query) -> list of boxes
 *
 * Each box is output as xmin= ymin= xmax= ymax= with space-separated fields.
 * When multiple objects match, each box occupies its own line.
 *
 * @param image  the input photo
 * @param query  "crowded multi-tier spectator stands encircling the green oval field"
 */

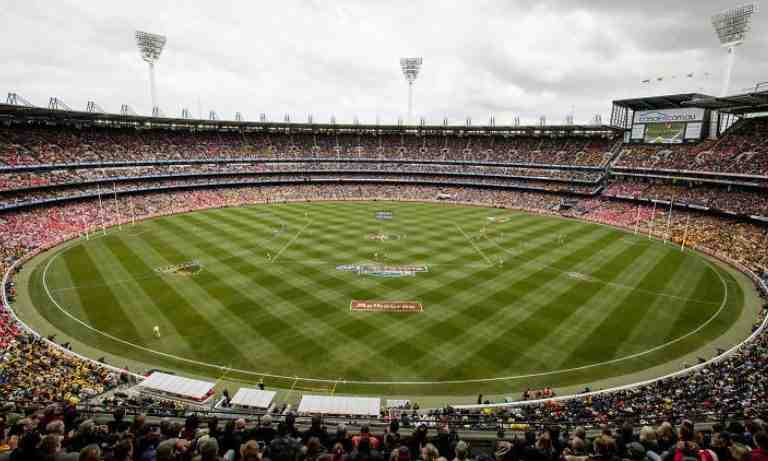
xmin=0 ymin=103 xmax=768 ymax=461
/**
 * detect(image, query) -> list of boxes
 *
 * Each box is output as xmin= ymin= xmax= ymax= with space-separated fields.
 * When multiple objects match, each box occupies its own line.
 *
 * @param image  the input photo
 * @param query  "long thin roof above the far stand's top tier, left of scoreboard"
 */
xmin=0 ymin=104 xmax=618 ymax=135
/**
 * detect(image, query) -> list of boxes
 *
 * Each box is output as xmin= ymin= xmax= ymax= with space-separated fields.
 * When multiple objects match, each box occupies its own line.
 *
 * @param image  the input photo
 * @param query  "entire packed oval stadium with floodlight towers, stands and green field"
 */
xmin=0 ymin=5 xmax=768 ymax=461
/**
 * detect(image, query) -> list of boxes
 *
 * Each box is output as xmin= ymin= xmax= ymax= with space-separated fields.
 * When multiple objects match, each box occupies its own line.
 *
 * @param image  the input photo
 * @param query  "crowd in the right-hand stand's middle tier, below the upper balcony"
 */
xmin=603 ymin=181 xmax=768 ymax=216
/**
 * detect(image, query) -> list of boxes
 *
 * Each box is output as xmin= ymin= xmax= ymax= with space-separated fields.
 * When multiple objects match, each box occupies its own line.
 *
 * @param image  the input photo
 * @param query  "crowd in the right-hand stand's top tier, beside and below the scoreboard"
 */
xmin=616 ymin=117 xmax=768 ymax=176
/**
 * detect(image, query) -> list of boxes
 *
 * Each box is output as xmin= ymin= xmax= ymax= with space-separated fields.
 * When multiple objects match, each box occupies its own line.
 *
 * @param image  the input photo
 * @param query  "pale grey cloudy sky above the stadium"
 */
xmin=0 ymin=0 xmax=768 ymax=124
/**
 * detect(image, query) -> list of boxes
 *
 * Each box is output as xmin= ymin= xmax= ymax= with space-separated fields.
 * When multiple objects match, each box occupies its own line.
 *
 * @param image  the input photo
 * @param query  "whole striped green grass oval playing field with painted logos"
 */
xmin=30 ymin=202 xmax=744 ymax=395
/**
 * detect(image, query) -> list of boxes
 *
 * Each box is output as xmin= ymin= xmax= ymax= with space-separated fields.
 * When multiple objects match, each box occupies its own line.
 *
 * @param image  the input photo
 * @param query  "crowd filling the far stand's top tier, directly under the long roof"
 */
xmin=0 ymin=125 xmax=616 ymax=166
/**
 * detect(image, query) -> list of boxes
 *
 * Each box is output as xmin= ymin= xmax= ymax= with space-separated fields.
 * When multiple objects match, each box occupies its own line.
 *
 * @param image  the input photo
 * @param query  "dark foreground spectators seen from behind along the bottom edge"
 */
xmin=0 ymin=398 xmax=768 ymax=461
